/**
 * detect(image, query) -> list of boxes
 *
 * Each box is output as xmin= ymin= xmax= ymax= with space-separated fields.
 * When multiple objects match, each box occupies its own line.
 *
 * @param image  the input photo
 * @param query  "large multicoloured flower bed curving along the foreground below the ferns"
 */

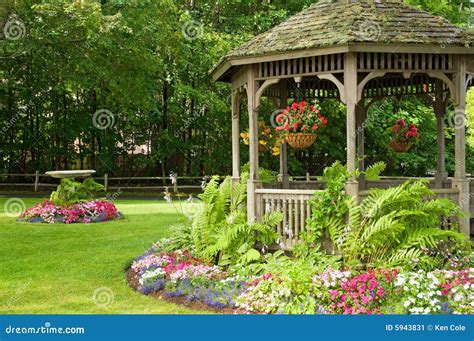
xmin=130 ymin=240 xmax=474 ymax=314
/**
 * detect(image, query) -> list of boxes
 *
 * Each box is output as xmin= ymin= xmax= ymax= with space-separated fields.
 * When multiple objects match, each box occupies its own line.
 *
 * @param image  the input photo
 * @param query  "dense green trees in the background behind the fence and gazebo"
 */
xmin=0 ymin=0 xmax=472 ymax=175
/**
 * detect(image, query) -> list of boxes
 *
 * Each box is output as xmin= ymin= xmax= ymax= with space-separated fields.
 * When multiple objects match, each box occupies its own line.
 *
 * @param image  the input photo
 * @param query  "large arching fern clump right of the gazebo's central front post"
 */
xmin=333 ymin=181 xmax=469 ymax=268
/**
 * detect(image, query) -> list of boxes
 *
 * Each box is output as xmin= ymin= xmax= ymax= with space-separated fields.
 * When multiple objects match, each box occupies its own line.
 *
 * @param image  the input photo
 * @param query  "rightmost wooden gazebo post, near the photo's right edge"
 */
xmin=453 ymin=56 xmax=470 ymax=238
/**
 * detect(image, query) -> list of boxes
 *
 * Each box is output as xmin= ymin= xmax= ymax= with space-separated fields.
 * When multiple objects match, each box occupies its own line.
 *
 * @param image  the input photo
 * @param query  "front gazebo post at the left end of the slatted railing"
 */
xmin=247 ymin=65 xmax=259 ymax=221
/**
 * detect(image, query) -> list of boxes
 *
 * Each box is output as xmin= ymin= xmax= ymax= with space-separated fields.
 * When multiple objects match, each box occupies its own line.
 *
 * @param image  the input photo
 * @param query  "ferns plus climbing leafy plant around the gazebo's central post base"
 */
xmin=304 ymin=163 xmax=470 ymax=267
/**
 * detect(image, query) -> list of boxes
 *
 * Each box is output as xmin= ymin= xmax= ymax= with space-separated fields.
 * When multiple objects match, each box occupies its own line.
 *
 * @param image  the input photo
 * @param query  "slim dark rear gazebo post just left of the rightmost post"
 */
xmin=433 ymin=79 xmax=448 ymax=188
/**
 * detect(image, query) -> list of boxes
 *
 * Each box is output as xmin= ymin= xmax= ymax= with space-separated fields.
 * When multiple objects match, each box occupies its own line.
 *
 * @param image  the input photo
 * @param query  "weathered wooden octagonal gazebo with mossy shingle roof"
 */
xmin=212 ymin=0 xmax=474 ymax=247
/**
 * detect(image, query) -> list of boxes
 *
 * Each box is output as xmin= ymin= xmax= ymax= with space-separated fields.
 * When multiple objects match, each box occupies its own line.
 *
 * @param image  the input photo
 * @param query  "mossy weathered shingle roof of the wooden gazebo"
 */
xmin=213 ymin=0 xmax=474 ymax=78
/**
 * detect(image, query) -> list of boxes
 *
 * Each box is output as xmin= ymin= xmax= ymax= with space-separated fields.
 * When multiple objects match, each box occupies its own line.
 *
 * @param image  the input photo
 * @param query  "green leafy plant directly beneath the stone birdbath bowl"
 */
xmin=50 ymin=178 xmax=105 ymax=206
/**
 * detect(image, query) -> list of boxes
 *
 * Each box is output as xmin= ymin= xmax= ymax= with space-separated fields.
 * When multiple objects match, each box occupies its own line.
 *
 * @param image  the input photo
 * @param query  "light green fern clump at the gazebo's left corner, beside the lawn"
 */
xmin=172 ymin=174 xmax=283 ymax=267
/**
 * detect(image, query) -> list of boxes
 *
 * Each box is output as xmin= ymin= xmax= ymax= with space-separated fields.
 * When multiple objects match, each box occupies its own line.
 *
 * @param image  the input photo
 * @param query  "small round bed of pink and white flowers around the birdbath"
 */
xmin=17 ymin=200 xmax=122 ymax=224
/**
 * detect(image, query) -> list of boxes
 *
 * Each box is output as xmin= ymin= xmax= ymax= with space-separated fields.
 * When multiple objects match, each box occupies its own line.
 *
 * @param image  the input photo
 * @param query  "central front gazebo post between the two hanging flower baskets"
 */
xmin=344 ymin=52 xmax=359 ymax=199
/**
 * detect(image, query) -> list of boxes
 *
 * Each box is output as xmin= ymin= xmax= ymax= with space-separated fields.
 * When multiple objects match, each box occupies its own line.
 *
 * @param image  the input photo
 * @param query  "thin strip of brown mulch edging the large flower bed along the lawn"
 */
xmin=127 ymin=269 xmax=248 ymax=315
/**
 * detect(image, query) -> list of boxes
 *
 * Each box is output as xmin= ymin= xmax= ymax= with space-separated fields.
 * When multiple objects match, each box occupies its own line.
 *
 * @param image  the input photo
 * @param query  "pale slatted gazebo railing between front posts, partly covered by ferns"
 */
xmin=255 ymin=188 xmax=316 ymax=250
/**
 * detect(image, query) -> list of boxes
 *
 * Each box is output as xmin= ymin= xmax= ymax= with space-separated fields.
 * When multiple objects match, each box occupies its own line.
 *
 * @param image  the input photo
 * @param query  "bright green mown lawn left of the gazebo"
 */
xmin=0 ymin=198 xmax=207 ymax=314
